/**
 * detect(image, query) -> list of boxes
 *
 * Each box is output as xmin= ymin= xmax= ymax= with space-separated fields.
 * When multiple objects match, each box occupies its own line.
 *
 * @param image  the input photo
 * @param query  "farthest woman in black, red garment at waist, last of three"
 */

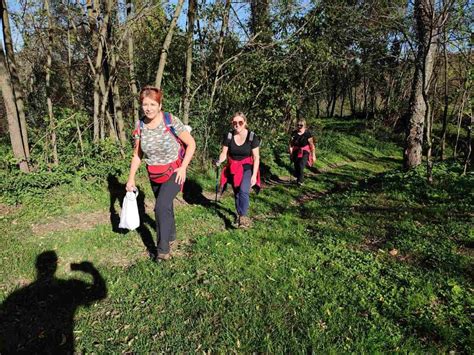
xmin=289 ymin=120 xmax=316 ymax=186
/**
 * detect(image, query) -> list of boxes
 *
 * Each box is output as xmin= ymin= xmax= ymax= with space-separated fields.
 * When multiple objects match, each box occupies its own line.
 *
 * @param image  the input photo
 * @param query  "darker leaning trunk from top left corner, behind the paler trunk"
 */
xmin=0 ymin=0 xmax=30 ymax=161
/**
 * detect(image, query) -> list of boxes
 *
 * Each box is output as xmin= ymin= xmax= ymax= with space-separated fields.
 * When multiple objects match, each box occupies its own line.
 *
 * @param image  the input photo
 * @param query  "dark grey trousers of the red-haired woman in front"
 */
xmin=151 ymin=173 xmax=181 ymax=254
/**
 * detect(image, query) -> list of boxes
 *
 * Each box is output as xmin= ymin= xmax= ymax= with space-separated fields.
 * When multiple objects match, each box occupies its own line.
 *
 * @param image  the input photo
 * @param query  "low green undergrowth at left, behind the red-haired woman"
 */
xmin=0 ymin=109 xmax=130 ymax=203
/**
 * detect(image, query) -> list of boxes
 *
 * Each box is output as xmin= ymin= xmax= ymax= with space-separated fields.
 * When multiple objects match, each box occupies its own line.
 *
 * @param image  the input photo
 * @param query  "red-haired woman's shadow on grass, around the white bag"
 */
xmin=107 ymin=174 xmax=156 ymax=258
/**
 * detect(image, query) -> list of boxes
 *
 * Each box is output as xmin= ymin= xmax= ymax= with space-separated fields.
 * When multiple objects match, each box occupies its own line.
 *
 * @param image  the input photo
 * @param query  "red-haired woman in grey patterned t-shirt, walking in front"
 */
xmin=126 ymin=86 xmax=196 ymax=261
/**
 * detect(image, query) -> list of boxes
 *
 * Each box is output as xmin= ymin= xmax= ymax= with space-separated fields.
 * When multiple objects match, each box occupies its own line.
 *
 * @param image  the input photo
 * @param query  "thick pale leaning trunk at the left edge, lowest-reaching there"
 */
xmin=0 ymin=42 xmax=30 ymax=172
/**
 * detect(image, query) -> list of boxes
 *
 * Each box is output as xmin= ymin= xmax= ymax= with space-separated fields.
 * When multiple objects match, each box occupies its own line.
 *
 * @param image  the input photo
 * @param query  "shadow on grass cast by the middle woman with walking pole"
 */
xmin=183 ymin=179 xmax=235 ymax=229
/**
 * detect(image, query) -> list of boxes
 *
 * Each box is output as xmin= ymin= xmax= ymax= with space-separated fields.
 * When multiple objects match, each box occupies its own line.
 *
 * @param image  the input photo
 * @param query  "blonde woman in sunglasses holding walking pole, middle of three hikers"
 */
xmin=216 ymin=112 xmax=260 ymax=228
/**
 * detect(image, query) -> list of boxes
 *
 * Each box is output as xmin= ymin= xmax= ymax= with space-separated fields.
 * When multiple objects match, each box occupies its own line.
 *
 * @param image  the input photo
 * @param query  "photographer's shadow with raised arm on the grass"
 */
xmin=0 ymin=250 xmax=107 ymax=354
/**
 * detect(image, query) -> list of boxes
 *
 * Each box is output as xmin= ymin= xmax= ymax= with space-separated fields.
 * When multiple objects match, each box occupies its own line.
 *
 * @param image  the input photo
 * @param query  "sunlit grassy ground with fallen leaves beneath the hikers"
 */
xmin=0 ymin=120 xmax=474 ymax=353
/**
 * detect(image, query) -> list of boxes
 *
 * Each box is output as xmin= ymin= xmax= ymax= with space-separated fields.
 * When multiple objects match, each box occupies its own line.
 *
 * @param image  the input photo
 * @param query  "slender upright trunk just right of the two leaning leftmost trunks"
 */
xmin=44 ymin=0 xmax=59 ymax=165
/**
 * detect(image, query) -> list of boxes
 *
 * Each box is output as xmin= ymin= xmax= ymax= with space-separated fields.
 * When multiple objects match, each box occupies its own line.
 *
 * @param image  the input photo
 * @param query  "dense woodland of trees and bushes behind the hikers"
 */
xmin=0 ymin=0 xmax=474 ymax=193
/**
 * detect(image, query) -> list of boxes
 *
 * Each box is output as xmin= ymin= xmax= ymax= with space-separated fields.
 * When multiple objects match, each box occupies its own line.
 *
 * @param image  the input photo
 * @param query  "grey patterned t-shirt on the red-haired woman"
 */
xmin=140 ymin=116 xmax=186 ymax=165
